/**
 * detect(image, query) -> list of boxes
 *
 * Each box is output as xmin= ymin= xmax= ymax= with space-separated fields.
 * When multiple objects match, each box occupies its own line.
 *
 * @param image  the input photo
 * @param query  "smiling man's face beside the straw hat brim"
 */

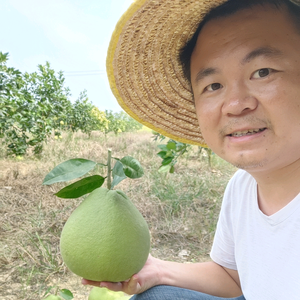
xmin=191 ymin=6 xmax=300 ymax=173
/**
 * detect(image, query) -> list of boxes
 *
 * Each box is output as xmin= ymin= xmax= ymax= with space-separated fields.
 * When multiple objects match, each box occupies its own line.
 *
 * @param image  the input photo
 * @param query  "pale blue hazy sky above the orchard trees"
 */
xmin=0 ymin=0 xmax=132 ymax=112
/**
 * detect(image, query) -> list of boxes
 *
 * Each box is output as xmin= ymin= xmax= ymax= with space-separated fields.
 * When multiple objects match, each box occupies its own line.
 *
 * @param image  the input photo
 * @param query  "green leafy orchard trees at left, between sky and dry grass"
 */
xmin=0 ymin=52 xmax=108 ymax=155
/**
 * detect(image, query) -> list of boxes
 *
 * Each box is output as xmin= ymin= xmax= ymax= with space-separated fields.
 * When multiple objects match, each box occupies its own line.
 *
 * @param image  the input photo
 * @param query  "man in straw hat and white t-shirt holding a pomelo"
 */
xmin=83 ymin=0 xmax=300 ymax=300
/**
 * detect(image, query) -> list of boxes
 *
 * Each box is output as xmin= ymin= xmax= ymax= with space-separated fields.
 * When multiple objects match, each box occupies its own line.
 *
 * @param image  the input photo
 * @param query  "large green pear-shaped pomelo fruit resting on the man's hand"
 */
xmin=60 ymin=188 xmax=150 ymax=282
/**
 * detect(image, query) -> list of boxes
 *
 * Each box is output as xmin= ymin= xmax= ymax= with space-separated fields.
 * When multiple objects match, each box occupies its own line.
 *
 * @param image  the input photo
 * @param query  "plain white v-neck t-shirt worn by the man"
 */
xmin=211 ymin=170 xmax=300 ymax=300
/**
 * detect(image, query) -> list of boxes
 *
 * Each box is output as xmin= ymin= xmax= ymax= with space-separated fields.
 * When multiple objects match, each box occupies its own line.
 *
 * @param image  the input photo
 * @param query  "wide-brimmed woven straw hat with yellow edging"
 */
xmin=107 ymin=0 xmax=226 ymax=146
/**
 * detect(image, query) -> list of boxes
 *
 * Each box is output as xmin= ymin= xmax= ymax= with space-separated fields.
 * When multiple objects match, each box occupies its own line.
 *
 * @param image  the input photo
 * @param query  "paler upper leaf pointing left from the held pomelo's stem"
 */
xmin=43 ymin=158 xmax=97 ymax=185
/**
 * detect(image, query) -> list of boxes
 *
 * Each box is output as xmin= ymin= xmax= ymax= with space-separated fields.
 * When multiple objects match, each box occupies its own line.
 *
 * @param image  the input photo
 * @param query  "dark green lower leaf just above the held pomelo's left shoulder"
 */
xmin=55 ymin=175 xmax=105 ymax=199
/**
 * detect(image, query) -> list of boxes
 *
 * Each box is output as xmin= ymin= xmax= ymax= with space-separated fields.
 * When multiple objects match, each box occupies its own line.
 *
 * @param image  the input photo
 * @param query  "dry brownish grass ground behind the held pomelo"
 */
xmin=0 ymin=132 xmax=235 ymax=300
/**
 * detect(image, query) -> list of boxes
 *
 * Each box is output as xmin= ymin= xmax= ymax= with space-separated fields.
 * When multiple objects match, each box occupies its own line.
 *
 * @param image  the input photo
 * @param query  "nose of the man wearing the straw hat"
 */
xmin=222 ymin=85 xmax=258 ymax=116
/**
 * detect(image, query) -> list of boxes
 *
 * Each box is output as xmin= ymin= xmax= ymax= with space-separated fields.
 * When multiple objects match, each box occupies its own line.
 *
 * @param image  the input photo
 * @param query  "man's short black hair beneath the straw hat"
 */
xmin=180 ymin=0 xmax=300 ymax=82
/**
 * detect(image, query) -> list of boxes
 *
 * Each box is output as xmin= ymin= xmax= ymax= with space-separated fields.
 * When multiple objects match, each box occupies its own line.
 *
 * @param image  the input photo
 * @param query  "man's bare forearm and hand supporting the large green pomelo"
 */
xmin=82 ymin=255 xmax=242 ymax=298
